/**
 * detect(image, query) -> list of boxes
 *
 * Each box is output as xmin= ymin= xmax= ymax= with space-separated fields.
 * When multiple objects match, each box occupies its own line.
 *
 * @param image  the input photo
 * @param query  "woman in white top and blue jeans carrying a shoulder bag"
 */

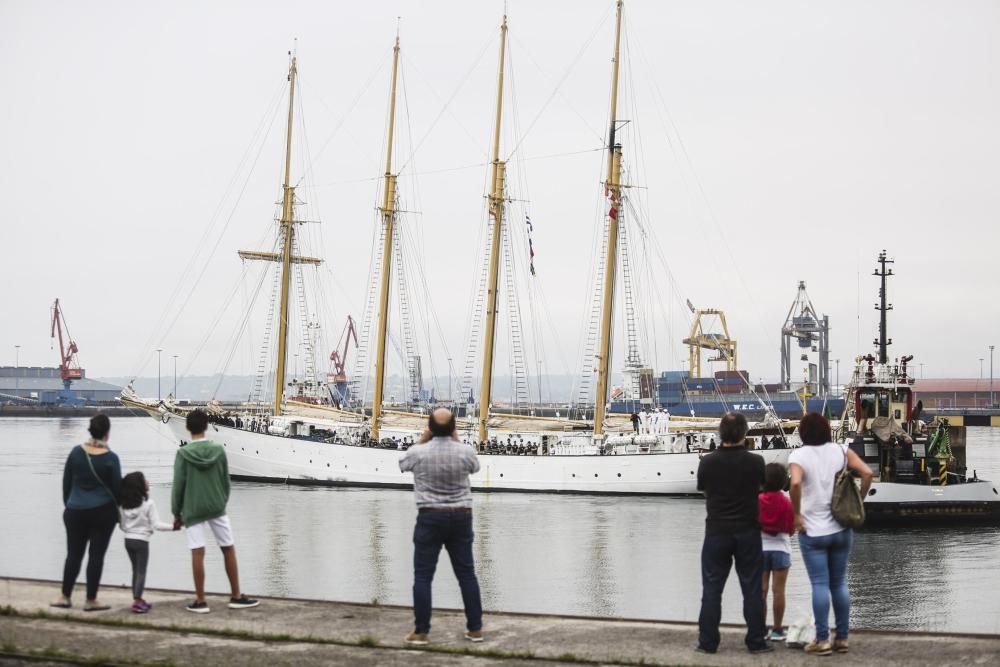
xmin=788 ymin=412 xmax=872 ymax=655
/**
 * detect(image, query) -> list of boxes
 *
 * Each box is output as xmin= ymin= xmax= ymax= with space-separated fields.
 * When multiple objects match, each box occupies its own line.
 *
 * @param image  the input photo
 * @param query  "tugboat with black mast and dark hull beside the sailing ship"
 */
xmin=837 ymin=250 xmax=1000 ymax=524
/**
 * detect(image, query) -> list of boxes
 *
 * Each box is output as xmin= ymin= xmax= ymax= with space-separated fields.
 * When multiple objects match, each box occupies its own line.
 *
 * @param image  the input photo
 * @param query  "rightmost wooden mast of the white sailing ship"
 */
xmin=594 ymin=0 xmax=624 ymax=438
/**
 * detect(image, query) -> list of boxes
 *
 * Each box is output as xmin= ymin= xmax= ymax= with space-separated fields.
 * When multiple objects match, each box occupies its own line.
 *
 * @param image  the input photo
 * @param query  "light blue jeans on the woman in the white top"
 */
xmin=799 ymin=528 xmax=854 ymax=641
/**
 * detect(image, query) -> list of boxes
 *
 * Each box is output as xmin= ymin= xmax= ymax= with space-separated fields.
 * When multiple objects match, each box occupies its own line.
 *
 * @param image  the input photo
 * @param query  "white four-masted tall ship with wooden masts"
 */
xmin=122 ymin=0 xmax=794 ymax=495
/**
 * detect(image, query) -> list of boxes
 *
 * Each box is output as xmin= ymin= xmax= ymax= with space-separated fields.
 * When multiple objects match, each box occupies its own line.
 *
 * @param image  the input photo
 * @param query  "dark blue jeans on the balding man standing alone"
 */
xmin=413 ymin=512 xmax=483 ymax=634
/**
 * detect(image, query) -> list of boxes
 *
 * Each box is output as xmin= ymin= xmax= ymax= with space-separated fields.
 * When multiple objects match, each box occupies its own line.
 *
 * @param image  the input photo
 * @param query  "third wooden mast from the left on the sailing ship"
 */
xmin=479 ymin=15 xmax=507 ymax=442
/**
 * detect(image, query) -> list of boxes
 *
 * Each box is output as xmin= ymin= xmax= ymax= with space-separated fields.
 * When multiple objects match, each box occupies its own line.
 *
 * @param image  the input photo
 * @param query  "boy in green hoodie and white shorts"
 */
xmin=171 ymin=410 xmax=260 ymax=614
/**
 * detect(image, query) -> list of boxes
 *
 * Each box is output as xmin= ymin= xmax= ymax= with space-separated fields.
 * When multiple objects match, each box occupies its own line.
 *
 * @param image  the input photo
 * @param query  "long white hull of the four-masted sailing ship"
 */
xmin=154 ymin=412 xmax=790 ymax=495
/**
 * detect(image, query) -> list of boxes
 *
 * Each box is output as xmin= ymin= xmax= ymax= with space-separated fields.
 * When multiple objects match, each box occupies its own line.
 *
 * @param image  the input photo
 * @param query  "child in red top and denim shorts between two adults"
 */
xmin=757 ymin=463 xmax=795 ymax=641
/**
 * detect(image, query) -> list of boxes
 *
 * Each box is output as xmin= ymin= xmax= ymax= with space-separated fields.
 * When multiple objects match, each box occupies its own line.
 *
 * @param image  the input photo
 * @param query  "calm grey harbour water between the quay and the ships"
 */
xmin=0 ymin=418 xmax=1000 ymax=633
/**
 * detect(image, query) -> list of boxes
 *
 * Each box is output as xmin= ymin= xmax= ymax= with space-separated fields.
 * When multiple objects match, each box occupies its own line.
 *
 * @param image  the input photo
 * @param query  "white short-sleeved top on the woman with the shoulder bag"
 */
xmin=788 ymin=442 xmax=847 ymax=537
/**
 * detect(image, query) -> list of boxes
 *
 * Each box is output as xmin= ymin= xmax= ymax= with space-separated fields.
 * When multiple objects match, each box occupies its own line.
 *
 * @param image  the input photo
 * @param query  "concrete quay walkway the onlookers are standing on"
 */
xmin=0 ymin=579 xmax=1000 ymax=667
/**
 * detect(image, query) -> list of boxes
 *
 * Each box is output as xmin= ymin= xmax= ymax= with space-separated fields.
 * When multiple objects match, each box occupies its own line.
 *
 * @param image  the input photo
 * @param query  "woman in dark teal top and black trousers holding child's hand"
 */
xmin=52 ymin=414 xmax=122 ymax=611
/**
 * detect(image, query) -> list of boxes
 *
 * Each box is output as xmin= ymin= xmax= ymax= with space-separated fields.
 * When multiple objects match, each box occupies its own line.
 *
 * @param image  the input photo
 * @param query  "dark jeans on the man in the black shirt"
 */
xmin=698 ymin=528 xmax=767 ymax=651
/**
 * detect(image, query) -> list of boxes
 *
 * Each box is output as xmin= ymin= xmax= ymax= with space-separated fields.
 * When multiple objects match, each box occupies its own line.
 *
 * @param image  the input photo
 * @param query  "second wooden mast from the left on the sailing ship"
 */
xmin=371 ymin=33 xmax=399 ymax=441
